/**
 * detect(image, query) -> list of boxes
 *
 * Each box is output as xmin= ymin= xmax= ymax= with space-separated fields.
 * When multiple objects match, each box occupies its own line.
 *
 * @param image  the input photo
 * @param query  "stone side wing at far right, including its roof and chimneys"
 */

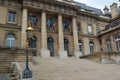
xmin=99 ymin=3 xmax=120 ymax=52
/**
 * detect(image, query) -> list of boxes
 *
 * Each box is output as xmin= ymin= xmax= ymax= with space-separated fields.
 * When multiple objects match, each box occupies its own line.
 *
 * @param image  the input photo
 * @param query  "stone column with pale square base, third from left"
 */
xmin=58 ymin=14 xmax=67 ymax=58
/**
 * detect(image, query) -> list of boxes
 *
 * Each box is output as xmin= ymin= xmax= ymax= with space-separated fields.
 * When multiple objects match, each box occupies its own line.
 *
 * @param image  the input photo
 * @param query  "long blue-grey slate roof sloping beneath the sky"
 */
xmin=74 ymin=2 xmax=104 ymax=15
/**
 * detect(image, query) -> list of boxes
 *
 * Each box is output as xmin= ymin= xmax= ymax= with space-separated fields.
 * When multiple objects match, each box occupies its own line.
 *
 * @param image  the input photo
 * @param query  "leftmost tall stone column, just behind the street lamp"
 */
xmin=21 ymin=8 xmax=28 ymax=48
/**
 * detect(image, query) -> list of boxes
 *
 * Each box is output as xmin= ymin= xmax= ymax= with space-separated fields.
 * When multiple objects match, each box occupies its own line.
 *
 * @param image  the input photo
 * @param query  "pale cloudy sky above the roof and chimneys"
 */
xmin=74 ymin=0 xmax=120 ymax=10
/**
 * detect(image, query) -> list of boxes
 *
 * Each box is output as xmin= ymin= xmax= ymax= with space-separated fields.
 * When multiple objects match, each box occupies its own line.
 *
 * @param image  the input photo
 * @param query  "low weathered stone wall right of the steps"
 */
xmin=81 ymin=52 xmax=120 ymax=64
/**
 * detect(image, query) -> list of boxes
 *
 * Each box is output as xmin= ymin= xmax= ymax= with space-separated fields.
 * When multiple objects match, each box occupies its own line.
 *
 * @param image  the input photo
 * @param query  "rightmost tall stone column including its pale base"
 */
xmin=72 ymin=17 xmax=82 ymax=58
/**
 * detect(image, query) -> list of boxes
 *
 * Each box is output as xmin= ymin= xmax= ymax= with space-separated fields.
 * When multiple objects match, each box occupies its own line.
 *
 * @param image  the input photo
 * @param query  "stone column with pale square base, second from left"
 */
xmin=40 ymin=11 xmax=50 ymax=57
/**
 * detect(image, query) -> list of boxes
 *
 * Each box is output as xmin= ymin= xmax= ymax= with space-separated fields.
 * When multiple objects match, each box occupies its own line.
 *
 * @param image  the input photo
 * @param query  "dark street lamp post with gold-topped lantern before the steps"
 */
xmin=22 ymin=22 xmax=34 ymax=78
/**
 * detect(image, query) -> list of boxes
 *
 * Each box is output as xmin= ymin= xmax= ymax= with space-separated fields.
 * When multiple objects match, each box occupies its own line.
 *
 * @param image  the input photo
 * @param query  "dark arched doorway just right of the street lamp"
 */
xmin=29 ymin=36 xmax=37 ymax=56
